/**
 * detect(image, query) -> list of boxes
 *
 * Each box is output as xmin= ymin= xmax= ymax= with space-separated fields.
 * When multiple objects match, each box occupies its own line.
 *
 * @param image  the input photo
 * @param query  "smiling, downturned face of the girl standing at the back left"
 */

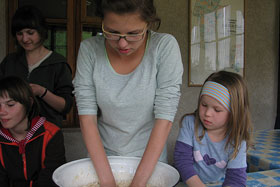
xmin=16 ymin=28 xmax=42 ymax=51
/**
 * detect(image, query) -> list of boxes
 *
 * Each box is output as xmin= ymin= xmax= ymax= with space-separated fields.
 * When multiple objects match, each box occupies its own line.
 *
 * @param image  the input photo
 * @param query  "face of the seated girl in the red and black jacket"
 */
xmin=0 ymin=96 xmax=28 ymax=134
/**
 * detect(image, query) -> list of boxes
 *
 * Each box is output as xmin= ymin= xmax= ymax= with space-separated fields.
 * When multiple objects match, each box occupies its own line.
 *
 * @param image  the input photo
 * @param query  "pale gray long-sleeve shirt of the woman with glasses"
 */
xmin=73 ymin=31 xmax=183 ymax=161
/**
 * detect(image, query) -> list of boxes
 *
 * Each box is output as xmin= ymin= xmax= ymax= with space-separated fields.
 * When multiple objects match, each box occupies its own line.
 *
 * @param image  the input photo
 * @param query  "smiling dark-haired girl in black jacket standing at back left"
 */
xmin=0 ymin=6 xmax=73 ymax=126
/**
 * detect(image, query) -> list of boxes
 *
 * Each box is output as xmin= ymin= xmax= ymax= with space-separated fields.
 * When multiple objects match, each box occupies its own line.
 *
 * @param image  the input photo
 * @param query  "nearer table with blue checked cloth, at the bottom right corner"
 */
xmin=173 ymin=169 xmax=280 ymax=187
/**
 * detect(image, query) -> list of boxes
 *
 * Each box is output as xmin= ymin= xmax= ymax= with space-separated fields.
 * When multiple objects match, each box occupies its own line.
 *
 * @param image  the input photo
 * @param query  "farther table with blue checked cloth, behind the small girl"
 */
xmin=247 ymin=130 xmax=280 ymax=172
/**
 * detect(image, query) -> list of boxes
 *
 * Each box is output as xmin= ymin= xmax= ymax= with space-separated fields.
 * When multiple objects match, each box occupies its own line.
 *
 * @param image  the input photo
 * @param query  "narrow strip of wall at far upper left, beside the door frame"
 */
xmin=0 ymin=0 xmax=6 ymax=62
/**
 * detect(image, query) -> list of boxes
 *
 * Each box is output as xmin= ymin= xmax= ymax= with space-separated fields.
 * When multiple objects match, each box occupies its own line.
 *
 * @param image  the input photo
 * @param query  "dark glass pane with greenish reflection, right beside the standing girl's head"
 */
xmin=44 ymin=26 xmax=67 ymax=57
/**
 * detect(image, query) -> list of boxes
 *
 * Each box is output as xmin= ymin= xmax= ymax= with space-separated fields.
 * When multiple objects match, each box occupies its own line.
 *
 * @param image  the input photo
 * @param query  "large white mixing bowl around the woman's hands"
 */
xmin=53 ymin=156 xmax=179 ymax=187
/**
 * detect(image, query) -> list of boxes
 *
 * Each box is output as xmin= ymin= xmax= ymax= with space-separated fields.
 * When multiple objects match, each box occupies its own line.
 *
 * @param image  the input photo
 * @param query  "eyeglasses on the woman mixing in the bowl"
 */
xmin=102 ymin=23 xmax=147 ymax=42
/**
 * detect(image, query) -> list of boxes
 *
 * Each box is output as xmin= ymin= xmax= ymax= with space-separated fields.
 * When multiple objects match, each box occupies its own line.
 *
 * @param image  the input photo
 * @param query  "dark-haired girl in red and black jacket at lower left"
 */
xmin=0 ymin=77 xmax=65 ymax=187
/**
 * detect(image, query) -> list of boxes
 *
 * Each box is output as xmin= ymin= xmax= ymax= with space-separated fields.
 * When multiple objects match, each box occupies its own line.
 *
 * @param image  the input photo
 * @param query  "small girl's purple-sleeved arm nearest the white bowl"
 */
xmin=174 ymin=141 xmax=205 ymax=187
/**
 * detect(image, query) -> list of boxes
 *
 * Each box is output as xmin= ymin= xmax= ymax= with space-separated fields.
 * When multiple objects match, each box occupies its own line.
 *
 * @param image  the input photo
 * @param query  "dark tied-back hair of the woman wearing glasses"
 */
xmin=96 ymin=0 xmax=161 ymax=29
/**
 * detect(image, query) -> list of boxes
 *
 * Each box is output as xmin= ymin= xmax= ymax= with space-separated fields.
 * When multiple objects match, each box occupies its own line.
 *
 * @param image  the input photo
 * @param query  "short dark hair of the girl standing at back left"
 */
xmin=11 ymin=5 xmax=48 ymax=48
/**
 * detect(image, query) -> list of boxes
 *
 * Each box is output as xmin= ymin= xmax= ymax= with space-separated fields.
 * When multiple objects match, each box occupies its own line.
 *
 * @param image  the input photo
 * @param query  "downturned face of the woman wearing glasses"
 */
xmin=103 ymin=12 xmax=147 ymax=56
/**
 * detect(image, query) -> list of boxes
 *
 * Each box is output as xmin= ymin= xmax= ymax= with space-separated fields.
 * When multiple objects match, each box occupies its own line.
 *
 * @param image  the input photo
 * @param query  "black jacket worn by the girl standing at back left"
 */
xmin=0 ymin=52 xmax=74 ymax=126
